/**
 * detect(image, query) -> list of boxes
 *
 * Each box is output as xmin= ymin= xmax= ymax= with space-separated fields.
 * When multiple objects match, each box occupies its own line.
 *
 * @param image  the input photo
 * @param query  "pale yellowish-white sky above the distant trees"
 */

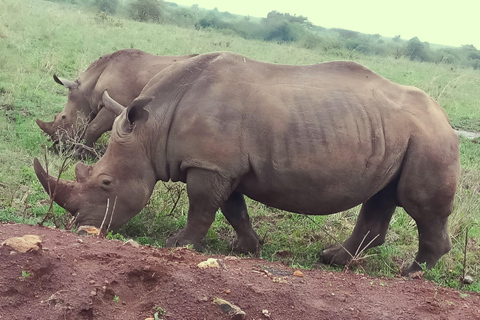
xmin=171 ymin=0 xmax=480 ymax=50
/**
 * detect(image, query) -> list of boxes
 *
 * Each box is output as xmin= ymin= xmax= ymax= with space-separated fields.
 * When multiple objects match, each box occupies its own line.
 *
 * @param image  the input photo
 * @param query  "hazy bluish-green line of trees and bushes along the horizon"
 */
xmin=50 ymin=0 xmax=480 ymax=69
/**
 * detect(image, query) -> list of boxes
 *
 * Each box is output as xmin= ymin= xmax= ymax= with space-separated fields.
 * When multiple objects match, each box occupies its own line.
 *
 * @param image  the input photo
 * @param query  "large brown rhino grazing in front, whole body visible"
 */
xmin=34 ymin=53 xmax=459 ymax=273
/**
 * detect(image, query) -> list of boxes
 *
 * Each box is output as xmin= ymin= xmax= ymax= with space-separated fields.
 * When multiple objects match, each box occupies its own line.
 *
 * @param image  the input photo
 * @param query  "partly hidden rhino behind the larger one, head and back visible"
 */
xmin=37 ymin=49 xmax=196 ymax=155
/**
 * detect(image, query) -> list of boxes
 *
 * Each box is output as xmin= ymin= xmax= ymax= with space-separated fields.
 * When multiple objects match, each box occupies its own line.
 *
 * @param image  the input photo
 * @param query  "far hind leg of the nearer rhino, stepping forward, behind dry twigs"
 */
xmin=320 ymin=183 xmax=397 ymax=265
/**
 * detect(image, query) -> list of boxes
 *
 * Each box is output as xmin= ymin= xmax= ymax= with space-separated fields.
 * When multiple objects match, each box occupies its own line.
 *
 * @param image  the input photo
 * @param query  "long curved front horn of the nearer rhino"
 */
xmin=33 ymin=158 xmax=78 ymax=213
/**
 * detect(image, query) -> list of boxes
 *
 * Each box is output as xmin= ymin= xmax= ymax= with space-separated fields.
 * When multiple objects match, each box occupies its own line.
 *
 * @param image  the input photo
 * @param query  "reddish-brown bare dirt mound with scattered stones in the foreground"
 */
xmin=0 ymin=224 xmax=480 ymax=320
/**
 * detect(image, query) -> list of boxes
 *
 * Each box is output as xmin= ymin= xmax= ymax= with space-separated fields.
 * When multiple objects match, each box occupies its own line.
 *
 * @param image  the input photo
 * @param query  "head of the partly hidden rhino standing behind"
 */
xmin=36 ymin=75 xmax=90 ymax=144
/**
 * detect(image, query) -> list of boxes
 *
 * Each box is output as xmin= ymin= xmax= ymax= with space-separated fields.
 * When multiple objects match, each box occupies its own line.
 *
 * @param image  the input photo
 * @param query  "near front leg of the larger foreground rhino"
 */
xmin=166 ymin=168 xmax=232 ymax=250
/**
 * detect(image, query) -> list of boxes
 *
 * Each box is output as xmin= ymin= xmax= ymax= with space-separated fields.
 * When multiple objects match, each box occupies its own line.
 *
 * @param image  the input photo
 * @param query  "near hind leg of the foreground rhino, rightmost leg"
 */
xmin=398 ymin=136 xmax=460 ymax=275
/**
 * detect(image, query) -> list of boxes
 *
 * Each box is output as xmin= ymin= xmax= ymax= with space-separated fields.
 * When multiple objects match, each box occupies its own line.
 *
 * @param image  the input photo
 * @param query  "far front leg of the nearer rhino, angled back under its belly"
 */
xmin=221 ymin=192 xmax=262 ymax=253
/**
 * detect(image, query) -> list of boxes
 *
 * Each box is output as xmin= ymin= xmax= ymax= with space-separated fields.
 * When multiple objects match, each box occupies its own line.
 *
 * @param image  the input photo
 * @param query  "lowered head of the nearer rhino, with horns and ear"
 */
xmin=34 ymin=93 xmax=157 ymax=231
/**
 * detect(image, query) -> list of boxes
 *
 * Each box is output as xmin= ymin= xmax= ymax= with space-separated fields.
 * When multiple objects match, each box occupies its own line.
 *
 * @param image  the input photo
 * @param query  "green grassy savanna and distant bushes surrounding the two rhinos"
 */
xmin=0 ymin=0 xmax=480 ymax=291
